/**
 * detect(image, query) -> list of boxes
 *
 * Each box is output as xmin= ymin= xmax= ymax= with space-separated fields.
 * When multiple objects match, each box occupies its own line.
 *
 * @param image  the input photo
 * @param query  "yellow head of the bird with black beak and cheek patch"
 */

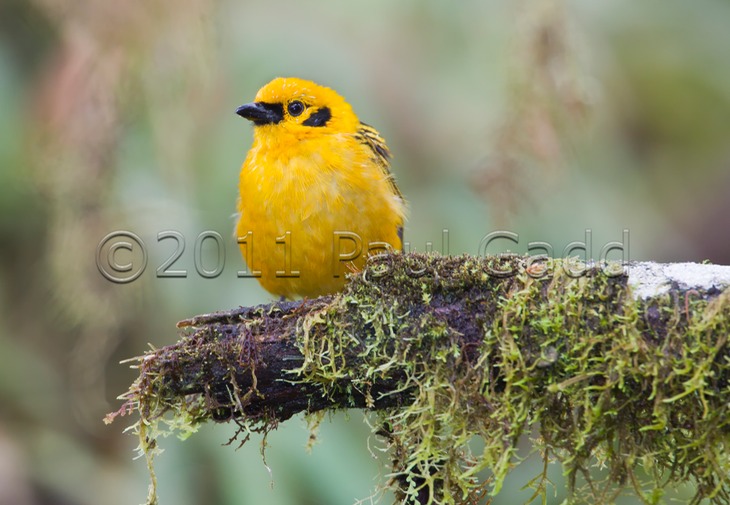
xmin=236 ymin=77 xmax=360 ymax=137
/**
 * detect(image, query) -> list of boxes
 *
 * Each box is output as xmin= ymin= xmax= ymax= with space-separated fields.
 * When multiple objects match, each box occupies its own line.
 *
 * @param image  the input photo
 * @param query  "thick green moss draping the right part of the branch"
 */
xmin=290 ymin=256 xmax=730 ymax=503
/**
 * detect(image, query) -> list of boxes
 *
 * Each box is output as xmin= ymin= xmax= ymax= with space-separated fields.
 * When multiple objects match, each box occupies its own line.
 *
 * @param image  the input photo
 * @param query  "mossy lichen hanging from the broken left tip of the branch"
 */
xmin=104 ymin=308 xmax=278 ymax=505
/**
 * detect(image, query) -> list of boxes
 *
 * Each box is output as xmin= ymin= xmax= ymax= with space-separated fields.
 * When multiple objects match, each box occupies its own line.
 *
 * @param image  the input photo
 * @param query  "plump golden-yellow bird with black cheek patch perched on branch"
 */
xmin=236 ymin=77 xmax=406 ymax=299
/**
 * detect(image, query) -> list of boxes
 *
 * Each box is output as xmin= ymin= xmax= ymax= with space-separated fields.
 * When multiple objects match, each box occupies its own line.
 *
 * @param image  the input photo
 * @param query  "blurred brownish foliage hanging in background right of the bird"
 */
xmin=474 ymin=2 xmax=596 ymax=226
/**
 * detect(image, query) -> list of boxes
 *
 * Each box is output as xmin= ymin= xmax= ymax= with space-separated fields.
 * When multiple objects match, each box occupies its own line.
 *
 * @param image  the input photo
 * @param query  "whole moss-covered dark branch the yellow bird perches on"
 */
xmin=109 ymin=254 xmax=730 ymax=503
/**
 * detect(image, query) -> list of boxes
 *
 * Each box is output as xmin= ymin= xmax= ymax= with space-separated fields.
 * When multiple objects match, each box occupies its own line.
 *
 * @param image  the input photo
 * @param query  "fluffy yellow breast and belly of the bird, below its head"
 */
xmin=236 ymin=132 xmax=405 ymax=299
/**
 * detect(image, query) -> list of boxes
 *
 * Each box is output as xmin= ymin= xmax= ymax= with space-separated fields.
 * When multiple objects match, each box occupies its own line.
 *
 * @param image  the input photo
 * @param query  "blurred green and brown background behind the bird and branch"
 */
xmin=0 ymin=0 xmax=730 ymax=505
